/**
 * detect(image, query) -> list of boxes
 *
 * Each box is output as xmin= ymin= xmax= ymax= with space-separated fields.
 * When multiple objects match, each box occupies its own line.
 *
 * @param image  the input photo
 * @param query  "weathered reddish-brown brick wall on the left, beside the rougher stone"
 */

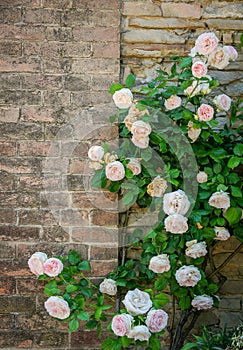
xmin=0 ymin=0 xmax=120 ymax=350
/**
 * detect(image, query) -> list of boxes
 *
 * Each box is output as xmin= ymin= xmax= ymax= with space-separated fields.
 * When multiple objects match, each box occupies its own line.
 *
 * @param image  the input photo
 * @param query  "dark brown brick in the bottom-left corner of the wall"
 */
xmin=0 ymin=330 xmax=34 ymax=349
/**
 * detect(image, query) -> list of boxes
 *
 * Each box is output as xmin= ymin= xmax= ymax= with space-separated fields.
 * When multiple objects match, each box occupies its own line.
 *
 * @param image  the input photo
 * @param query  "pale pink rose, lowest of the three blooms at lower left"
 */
xmin=44 ymin=297 xmax=70 ymax=320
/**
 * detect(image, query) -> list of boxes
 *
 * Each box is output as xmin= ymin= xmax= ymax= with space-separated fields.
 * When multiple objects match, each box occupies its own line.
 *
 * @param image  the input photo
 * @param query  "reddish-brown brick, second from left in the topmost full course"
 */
xmin=23 ymin=9 xmax=62 ymax=25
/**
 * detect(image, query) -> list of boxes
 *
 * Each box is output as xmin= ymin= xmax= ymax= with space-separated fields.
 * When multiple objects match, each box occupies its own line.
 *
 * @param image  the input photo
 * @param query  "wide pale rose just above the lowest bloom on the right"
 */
xmin=175 ymin=265 xmax=201 ymax=287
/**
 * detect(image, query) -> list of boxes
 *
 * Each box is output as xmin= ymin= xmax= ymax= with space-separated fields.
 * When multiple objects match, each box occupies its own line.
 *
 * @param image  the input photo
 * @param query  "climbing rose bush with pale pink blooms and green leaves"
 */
xmin=28 ymin=33 xmax=243 ymax=350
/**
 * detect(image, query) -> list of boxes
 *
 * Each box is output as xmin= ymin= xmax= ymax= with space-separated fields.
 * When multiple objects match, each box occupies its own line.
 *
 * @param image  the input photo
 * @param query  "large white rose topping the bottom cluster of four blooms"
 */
xmin=122 ymin=288 xmax=152 ymax=316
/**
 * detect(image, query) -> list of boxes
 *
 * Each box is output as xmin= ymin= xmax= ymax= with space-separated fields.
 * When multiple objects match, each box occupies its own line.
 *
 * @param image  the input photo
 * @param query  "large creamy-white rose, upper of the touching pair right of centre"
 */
xmin=163 ymin=190 xmax=190 ymax=215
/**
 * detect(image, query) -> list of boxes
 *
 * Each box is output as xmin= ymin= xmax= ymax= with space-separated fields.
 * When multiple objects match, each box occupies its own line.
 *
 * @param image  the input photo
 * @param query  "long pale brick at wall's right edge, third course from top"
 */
xmin=73 ymin=27 xmax=120 ymax=42
